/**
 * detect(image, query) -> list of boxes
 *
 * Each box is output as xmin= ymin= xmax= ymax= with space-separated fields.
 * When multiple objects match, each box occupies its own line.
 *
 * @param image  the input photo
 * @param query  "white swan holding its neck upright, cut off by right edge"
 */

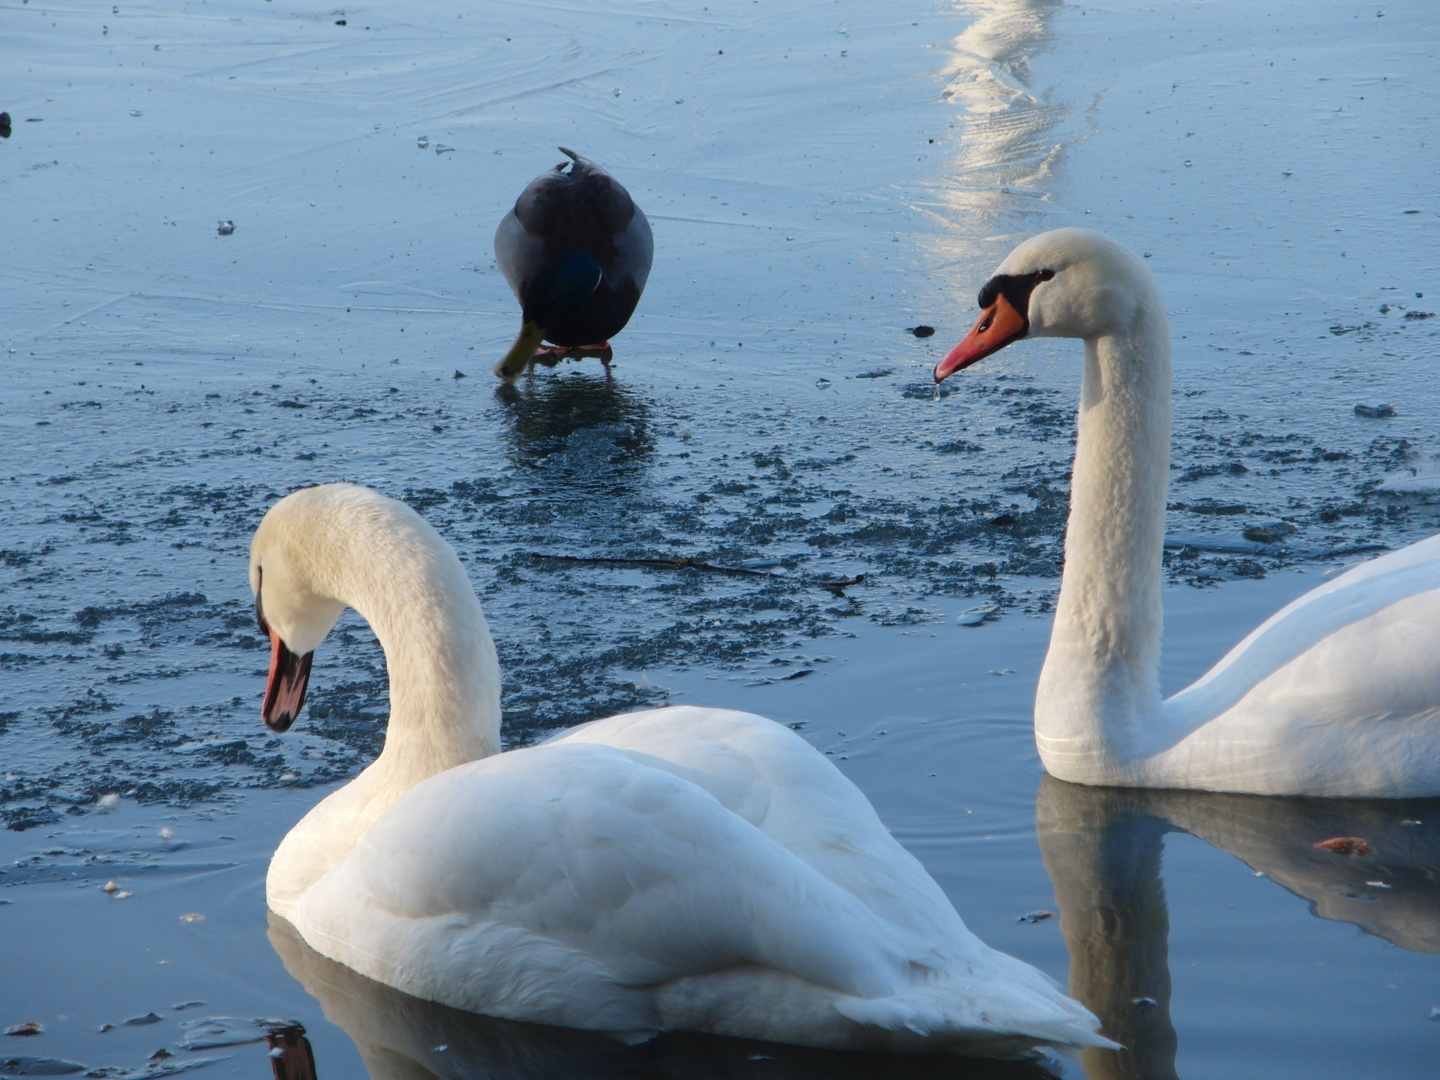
xmin=935 ymin=229 xmax=1440 ymax=798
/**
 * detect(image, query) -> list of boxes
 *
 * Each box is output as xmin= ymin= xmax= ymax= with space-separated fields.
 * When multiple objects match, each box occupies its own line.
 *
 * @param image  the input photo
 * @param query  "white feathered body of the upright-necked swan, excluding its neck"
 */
xmin=1138 ymin=537 xmax=1440 ymax=798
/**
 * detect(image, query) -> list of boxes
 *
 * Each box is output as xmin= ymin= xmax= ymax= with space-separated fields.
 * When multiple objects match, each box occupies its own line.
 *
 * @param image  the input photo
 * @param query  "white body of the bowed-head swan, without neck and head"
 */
xmin=294 ymin=707 xmax=1106 ymax=1054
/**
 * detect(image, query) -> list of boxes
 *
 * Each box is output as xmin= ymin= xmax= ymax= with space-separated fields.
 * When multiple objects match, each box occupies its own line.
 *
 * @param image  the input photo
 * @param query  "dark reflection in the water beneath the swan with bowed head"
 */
xmin=269 ymin=914 xmax=1054 ymax=1080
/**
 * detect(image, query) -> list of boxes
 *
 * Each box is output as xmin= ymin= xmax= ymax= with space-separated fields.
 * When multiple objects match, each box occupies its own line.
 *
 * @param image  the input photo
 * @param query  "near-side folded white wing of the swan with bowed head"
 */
xmin=297 ymin=744 xmax=914 ymax=1028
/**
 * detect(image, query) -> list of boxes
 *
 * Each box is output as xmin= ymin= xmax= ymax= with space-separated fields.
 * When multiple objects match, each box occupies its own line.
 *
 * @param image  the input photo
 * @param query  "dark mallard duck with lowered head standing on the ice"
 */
xmin=495 ymin=147 xmax=655 ymax=382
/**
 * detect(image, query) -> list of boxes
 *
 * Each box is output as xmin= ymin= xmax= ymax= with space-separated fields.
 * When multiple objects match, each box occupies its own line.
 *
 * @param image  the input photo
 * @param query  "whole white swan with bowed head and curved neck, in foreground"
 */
xmin=251 ymin=484 xmax=1112 ymax=1056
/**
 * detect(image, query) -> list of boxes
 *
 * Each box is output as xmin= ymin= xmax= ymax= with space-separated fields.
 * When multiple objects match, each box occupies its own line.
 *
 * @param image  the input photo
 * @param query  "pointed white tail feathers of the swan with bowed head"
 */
xmin=835 ymin=955 xmax=1120 ymax=1057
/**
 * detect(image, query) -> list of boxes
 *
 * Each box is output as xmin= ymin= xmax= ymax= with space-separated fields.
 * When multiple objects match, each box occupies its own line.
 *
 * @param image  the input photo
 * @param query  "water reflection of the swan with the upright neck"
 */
xmin=1035 ymin=776 xmax=1440 ymax=1080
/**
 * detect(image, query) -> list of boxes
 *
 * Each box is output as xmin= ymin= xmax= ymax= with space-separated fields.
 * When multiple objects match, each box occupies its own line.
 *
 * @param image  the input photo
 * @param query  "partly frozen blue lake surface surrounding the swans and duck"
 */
xmin=0 ymin=0 xmax=1440 ymax=1080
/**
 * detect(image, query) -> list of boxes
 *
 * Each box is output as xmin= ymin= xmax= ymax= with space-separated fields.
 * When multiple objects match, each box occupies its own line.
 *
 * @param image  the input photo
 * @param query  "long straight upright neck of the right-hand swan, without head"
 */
xmin=1035 ymin=300 xmax=1171 ymax=783
